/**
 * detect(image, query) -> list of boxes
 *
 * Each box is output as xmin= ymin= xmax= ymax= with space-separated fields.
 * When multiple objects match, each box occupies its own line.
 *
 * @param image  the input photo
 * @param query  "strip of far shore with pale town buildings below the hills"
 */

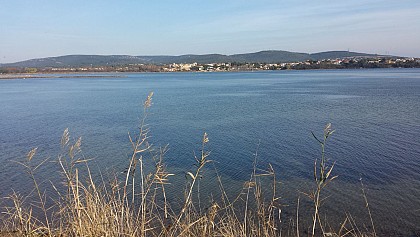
xmin=0 ymin=57 xmax=420 ymax=74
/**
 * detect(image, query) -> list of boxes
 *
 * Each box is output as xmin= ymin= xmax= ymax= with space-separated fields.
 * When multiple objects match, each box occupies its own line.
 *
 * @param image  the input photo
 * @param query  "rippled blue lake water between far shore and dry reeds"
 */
xmin=0 ymin=69 xmax=420 ymax=236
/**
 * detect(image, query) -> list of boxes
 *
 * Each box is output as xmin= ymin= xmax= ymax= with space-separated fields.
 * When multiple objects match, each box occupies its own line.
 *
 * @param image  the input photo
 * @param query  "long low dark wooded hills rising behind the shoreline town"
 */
xmin=0 ymin=50 xmax=388 ymax=68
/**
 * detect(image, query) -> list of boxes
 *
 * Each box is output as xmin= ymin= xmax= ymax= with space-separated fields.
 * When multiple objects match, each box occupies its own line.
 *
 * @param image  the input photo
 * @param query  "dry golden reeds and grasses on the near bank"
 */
xmin=0 ymin=93 xmax=376 ymax=236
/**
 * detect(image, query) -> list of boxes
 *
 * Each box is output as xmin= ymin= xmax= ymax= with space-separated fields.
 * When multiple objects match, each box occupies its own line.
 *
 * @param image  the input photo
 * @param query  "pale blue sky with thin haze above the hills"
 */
xmin=0 ymin=0 xmax=420 ymax=63
